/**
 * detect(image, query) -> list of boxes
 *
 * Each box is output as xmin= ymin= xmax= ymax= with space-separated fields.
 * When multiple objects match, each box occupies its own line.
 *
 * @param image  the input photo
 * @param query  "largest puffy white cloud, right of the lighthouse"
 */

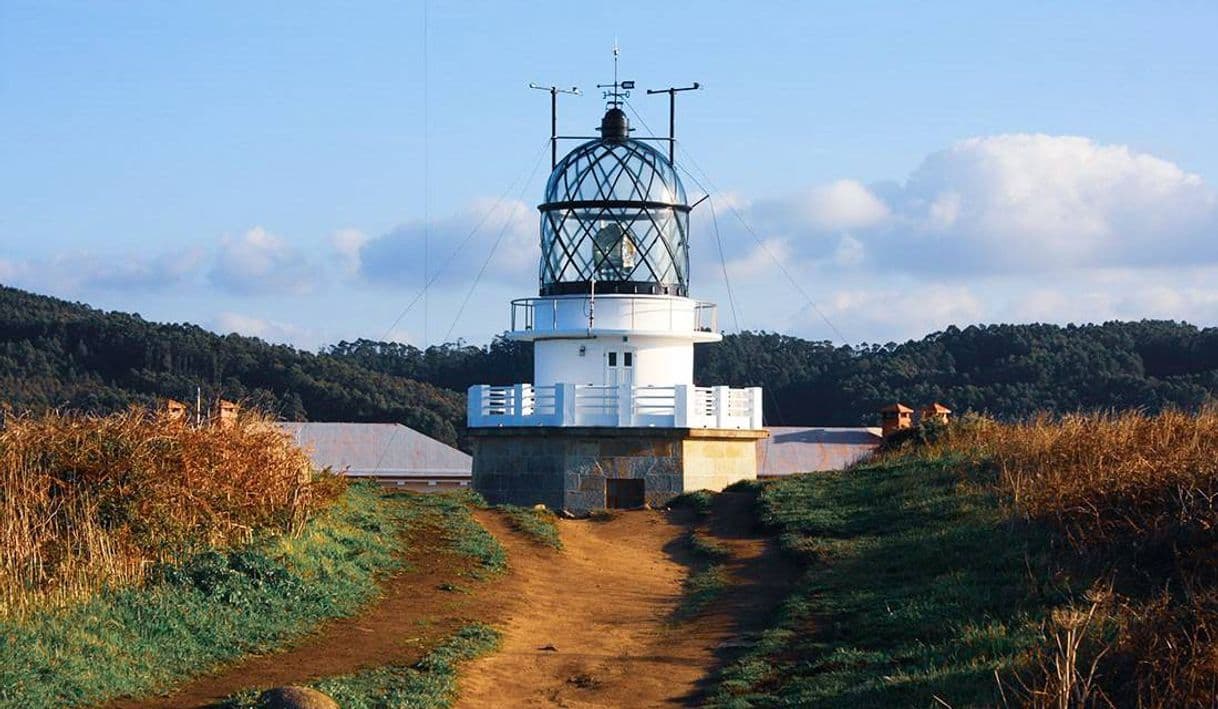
xmin=877 ymin=134 xmax=1218 ymax=272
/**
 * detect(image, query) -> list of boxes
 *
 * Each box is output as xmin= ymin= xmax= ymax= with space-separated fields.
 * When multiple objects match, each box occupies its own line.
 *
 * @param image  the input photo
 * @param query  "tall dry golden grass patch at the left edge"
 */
xmin=0 ymin=409 xmax=336 ymax=615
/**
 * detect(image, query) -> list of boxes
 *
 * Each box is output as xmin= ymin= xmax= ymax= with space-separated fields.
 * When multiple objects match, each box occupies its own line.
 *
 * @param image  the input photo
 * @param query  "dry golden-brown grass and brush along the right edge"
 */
xmin=906 ymin=408 xmax=1218 ymax=707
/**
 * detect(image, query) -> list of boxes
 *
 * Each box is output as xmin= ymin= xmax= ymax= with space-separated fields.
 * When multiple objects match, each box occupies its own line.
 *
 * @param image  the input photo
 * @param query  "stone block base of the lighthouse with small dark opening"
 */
xmin=469 ymin=426 xmax=770 ymax=513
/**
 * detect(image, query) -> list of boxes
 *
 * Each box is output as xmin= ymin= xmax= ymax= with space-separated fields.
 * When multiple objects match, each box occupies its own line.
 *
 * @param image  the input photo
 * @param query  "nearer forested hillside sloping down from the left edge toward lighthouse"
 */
xmin=0 ymin=286 xmax=465 ymax=443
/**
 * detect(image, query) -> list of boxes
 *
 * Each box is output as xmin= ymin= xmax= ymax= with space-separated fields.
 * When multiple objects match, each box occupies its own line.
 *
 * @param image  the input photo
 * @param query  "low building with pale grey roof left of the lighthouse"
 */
xmin=279 ymin=423 xmax=473 ymax=492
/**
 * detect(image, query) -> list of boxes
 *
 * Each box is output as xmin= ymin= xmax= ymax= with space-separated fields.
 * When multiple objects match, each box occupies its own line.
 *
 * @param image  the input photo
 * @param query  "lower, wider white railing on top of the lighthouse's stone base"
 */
xmin=468 ymin=384 xmax=761 ymax=429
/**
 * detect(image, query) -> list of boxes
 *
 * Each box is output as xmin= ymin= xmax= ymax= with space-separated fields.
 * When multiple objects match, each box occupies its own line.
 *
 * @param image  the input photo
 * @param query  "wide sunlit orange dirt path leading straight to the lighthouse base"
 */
xmin=458 ymin=495 xmax=790 ymax=707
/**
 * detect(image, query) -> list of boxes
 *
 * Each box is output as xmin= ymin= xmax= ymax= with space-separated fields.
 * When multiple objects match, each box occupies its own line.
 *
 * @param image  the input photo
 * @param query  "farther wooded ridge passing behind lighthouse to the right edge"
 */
xmin=328 ymin=320 xmax=1218 ymax=425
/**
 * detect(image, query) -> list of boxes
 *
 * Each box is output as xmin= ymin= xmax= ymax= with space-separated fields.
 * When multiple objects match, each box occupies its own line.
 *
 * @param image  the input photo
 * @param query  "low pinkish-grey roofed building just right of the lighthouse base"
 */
xmin=758 ymin=426 xmax=884 ymax=479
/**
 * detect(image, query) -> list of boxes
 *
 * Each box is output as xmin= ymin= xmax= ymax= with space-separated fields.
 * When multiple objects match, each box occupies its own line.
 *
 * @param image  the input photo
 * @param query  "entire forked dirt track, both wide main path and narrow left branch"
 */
xmin=112 ymin=495 xmax=792 ymax=707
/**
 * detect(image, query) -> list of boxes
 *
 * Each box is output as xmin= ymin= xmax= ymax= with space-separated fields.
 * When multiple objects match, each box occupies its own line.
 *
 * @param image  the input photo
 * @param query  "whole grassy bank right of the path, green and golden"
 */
xmin=708 ymin=409 xmax=1218 ymax=708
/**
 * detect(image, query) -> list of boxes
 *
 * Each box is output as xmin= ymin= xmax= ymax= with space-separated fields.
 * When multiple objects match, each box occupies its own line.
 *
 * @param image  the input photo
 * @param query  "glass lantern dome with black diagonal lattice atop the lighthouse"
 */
xmin=538 ymin=107 xmax=689 ymax=296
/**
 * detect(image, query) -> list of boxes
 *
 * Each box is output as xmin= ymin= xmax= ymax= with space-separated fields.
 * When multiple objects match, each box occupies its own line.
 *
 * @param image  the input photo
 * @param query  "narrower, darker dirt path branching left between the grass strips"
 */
xmin=110 ymin=521 xmax=503 ymax=708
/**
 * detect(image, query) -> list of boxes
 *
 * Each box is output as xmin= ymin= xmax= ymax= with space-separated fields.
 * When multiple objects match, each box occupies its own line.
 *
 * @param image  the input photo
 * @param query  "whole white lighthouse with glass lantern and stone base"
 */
xmin=468 ymin=74 xmax=767 ymax=512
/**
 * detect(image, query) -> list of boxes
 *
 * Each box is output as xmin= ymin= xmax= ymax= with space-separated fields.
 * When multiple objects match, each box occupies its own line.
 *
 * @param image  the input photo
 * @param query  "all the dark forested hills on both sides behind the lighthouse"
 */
xmin=0 ymin=287 xmax=1218 ymax=442
